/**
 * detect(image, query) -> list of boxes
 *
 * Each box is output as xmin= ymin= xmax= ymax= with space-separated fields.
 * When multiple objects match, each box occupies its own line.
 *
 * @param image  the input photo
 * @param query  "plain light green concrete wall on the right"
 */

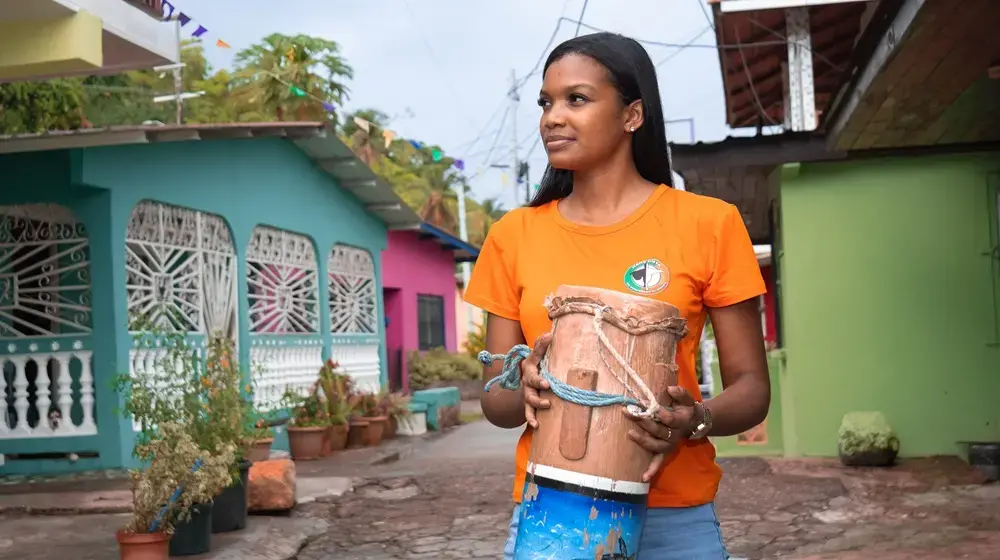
xmin=775 ymin=154 xmax=1000 ymax=456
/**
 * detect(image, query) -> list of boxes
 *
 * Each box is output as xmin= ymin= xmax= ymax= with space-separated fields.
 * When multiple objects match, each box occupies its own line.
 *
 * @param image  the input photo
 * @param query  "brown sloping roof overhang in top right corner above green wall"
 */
xmin=820 ymin=0 xmax=1000 ymax=150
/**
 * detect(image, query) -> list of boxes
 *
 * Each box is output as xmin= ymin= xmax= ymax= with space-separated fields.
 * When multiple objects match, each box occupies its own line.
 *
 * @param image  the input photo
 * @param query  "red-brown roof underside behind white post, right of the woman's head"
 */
xmin=712 ymin=0 xmax=872 ymax=128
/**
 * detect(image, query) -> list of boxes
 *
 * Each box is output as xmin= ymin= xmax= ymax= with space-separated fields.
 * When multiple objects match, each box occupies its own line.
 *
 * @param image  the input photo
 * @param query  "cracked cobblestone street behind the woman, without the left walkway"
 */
xmin=295 ymin=424 xmax=1000 ymax=560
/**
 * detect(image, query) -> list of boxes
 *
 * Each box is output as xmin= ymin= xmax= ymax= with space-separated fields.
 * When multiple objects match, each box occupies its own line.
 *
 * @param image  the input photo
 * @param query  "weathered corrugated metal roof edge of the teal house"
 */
xmin=0 ymin=122 xmax=421 ymax=229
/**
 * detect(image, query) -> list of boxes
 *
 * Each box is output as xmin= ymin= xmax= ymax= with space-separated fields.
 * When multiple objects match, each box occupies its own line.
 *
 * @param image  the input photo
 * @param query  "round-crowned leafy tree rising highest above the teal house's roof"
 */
xmin=235 ymin=33 xmax=354 ymax=121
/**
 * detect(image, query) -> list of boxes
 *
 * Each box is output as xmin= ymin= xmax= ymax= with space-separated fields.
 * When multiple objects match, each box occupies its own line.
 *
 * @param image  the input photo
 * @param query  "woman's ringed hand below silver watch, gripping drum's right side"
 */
xmin=625 ymin=387 xmax=697 ymax=482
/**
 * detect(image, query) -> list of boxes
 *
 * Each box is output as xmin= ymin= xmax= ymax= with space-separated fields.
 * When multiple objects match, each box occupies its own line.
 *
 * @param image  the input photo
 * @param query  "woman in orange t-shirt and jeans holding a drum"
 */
xmin=466 ymin=33 xmax=770 ymax=560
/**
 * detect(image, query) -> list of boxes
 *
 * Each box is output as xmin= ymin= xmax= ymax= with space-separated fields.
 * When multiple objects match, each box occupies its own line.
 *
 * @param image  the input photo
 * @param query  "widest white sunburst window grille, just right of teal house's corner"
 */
xmin=125 ymin=201 xmax=236 ymax=336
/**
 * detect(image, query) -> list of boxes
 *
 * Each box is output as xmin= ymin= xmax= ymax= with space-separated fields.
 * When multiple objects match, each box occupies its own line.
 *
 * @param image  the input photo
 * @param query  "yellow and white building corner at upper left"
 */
xmin=0 ymin=0 xmax=179 ymax=82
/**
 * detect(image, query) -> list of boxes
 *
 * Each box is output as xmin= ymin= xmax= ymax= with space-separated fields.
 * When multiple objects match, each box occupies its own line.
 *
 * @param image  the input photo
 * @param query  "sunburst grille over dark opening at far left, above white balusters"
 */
xmin=0 ymin=204 xmax=91 ymax=338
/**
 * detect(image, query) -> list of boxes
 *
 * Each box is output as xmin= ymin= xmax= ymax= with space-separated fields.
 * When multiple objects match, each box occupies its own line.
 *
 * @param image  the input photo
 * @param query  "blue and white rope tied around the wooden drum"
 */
xmin=478 ymin=298 xmax=686 ymax=418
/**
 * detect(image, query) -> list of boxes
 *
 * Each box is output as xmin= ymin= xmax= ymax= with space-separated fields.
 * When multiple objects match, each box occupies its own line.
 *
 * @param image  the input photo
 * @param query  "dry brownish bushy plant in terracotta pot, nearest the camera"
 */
xmin=115 ymin=422 xmax=235 ymax=560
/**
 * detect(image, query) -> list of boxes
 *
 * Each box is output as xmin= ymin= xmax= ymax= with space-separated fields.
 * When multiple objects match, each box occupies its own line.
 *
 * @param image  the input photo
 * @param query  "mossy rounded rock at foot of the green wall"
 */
xmin=837 ymin=412 xmax=899 ymax=467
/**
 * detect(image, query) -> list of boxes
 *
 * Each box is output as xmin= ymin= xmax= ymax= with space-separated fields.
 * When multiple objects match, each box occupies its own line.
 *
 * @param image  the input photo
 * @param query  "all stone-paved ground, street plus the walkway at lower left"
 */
xmin=0 ymin=421 xmax=1000 ymax=560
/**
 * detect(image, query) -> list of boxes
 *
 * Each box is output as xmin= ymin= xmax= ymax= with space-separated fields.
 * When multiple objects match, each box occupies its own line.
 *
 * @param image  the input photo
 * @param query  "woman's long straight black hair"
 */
xmin=530 ymin=32 xmax=673 ymax=206
